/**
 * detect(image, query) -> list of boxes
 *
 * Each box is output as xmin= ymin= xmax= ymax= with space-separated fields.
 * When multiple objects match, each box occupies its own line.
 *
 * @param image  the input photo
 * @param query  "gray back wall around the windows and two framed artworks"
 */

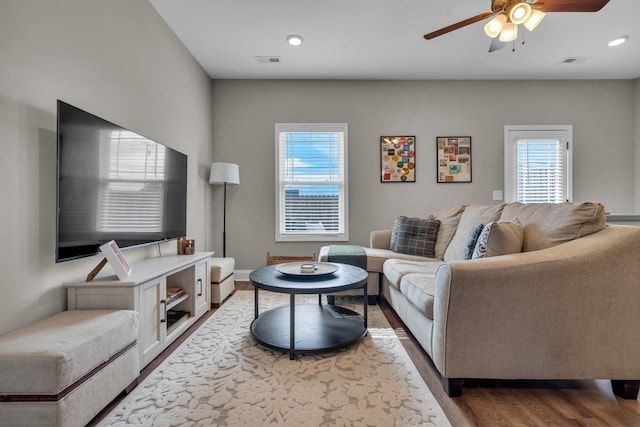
xmin=212 ymin=80 xmax=639 ymax=270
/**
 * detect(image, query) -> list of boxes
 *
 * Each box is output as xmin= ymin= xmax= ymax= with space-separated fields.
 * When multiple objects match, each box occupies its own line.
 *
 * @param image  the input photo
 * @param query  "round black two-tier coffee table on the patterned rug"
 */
xmin=249 ymin=263 xmax=367 ymax=360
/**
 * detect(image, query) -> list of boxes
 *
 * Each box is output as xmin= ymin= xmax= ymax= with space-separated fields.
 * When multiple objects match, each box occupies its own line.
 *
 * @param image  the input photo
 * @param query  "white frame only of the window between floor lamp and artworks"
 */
xmin=275 ymin=123 xmax=349 ymax=242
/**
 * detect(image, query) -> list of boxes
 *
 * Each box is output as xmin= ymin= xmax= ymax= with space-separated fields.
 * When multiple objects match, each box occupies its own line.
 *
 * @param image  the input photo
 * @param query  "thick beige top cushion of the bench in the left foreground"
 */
xmin=0 ymin=310 xmax=139 ymax=395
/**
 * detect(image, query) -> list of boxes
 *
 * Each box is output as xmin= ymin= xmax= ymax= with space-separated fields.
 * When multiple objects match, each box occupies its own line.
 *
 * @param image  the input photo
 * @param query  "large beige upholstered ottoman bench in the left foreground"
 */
xmin=0 ymin=310 xmax=140 ymax=427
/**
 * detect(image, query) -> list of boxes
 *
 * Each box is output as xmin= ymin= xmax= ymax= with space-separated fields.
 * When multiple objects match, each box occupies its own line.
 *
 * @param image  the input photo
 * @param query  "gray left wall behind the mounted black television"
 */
xmin=0 ymin=0 xmax=213 ymax=333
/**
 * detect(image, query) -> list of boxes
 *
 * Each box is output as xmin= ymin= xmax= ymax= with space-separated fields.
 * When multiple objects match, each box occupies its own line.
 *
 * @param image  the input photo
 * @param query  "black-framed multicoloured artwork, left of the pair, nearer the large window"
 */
xmin=380 ymin=136 xmax=416 ymax=182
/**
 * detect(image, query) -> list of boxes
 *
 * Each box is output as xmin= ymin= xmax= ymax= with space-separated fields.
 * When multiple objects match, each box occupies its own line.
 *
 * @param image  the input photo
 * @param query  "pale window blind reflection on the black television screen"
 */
xmin=96 ymin=131 xmax=165 ymax=233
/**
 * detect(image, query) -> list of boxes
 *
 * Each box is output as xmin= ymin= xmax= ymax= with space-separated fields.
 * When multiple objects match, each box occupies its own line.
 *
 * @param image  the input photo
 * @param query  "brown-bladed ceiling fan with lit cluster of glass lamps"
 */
xmin=424 ymin=0 xmax=609 ymax=52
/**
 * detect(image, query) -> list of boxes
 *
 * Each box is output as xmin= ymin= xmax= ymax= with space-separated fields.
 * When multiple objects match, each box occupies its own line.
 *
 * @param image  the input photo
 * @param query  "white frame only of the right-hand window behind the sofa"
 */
xmin=504 ymin=125 xmax=573 ymax=203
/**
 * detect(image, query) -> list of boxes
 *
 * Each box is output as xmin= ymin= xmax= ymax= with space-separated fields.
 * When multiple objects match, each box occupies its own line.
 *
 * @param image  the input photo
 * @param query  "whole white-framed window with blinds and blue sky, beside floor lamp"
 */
xmin=275 ymin=123 xmax=349 ymax=242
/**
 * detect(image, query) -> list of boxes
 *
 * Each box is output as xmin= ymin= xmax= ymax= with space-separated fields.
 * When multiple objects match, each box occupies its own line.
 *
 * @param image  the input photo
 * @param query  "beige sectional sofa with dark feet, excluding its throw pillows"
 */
xmin=330 ymin=203 xmax=640 ymax=399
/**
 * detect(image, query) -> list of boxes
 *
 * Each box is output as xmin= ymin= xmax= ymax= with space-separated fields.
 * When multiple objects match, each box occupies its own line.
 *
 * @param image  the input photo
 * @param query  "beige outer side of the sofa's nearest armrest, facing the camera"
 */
xmin=432 ymin=226 xmax=640 ymax=379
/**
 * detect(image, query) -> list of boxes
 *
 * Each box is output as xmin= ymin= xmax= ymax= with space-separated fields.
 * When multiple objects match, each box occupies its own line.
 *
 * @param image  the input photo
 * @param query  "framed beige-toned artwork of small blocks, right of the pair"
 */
xmin=436 ymin=136 xmax=471 ymax=183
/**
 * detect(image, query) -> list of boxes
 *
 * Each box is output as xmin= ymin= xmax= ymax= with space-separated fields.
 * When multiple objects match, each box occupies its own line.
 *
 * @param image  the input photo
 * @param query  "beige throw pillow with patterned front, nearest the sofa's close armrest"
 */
xmin=471 ymin=218 xmax=524 ymax=259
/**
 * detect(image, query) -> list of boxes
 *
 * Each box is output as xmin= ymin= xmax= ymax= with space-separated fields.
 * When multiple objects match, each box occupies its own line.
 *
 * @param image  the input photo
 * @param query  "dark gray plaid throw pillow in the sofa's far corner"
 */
xmin=393 ymin=216 xmax=440 ymax=258
